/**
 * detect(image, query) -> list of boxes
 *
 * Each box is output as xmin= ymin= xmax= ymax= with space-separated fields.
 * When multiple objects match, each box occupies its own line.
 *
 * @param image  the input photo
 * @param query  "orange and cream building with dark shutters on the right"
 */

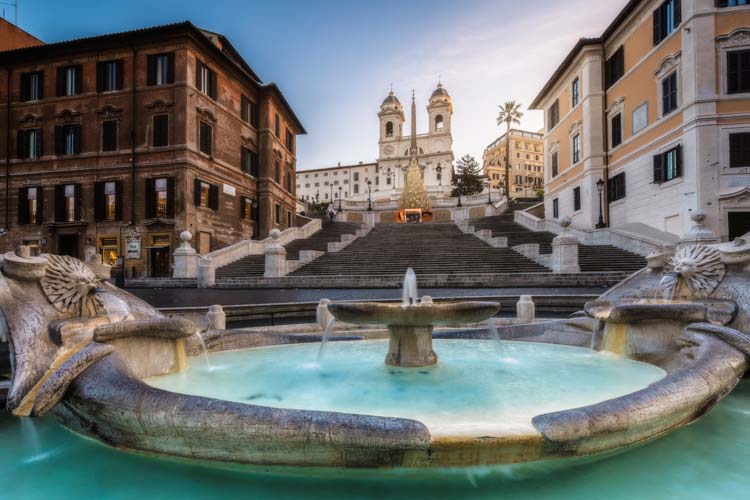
xmin=532 ymin=0 xmax=750 ymax=239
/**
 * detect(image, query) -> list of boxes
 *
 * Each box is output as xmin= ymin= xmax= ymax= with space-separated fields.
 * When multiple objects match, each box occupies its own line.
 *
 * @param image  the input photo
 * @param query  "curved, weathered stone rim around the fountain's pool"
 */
xmin=53 ymin=322 xmax=747 ymax=468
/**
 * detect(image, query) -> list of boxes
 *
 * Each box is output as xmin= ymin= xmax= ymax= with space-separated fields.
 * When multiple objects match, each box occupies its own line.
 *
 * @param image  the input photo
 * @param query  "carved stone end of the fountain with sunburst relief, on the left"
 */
xmin=0 ymin=246 xmax=195 ymax=416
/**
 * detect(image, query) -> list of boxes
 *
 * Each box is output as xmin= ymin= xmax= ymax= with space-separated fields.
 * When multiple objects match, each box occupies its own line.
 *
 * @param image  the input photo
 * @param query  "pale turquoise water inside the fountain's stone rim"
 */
xmin=148 ymin=340 xmax=664 ymax=435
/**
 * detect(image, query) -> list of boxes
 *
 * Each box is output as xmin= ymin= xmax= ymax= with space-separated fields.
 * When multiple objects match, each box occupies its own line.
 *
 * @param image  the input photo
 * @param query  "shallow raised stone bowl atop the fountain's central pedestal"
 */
xmin=328 ymin=302 xmax=500 ymax=327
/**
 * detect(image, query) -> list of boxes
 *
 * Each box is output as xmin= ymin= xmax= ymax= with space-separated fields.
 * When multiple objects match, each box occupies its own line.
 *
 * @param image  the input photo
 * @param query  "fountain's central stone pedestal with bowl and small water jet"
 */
xmin=328 ymin=269 xmax=500 ymax=368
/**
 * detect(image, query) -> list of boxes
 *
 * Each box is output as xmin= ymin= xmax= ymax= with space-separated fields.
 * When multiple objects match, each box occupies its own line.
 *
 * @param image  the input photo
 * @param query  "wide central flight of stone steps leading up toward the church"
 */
xmin=290 ymin=223 xmax=550 ymax=277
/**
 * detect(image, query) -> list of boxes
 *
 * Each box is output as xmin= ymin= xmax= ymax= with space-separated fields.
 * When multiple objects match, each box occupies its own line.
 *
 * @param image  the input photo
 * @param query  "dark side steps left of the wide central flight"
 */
xmin=216 ymin=221 xmax=361 ymax=286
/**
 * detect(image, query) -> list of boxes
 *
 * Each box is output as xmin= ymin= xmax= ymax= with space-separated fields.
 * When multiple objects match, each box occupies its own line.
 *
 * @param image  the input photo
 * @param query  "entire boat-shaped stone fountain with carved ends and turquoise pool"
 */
xmin=0 ymin=213 xmax=750 ymax=468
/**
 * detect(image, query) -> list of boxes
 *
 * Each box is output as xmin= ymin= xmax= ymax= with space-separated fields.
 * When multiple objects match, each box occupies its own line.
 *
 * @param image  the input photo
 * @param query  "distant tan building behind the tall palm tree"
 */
xmin=482 ymin=129 xmax=544 ymax=198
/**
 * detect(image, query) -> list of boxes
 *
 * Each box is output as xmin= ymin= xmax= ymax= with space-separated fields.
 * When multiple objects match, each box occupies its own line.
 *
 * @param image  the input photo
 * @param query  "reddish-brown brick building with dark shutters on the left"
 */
xmin=0 ymin=22 xmax=305 ymax=276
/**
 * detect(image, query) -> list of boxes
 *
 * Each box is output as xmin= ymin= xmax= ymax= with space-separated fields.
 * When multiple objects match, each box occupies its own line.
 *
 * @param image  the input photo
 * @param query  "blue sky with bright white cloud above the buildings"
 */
xmin=7 ymin=0 xmax=626 ymax=170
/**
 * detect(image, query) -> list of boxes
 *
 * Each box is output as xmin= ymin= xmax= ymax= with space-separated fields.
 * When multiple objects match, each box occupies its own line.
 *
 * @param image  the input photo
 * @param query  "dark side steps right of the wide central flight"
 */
xmin=470 ymin=210 xmax=646 ymax=273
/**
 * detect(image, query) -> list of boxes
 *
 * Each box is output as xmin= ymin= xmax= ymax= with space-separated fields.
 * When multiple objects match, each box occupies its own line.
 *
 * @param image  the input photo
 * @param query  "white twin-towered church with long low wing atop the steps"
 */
xmin=296 ymin=84 xmax=454 ymax=202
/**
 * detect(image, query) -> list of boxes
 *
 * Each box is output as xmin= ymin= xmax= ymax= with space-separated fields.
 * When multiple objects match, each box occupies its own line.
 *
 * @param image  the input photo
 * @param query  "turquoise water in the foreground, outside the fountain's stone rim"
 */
xmin=0 ymin=381 xmax=750 ymax=500
